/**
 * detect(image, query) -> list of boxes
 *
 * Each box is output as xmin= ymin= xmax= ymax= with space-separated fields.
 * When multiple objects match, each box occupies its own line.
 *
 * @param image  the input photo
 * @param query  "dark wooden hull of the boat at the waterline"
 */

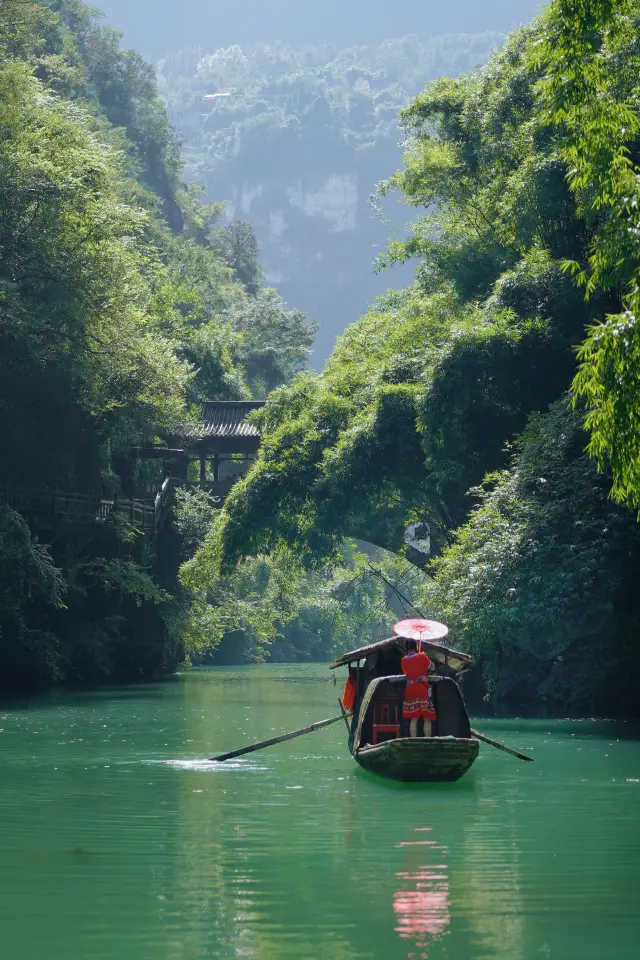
xmin=354 ymin=737 xmax=480 ymax=783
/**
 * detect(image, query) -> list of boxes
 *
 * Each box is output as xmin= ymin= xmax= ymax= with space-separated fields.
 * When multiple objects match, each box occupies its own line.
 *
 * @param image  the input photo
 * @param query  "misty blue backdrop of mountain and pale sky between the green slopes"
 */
xmin=97 ymin=0 xmax=539 ymax=360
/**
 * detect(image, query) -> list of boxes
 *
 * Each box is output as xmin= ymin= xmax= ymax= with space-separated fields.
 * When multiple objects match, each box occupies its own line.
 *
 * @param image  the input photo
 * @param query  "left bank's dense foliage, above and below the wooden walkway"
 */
xmin=0 ymin=0 xmax=313 ymax=687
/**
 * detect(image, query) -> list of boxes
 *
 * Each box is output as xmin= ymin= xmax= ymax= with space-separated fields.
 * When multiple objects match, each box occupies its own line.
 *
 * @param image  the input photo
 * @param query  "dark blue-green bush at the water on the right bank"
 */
xmin=422 ymin=399 xmax=640 ymax=716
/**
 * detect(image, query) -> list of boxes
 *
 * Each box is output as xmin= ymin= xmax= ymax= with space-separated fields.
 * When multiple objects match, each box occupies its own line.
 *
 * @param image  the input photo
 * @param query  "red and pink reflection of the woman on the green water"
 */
xmin=393 ymin=827 xmax=451 ymax=960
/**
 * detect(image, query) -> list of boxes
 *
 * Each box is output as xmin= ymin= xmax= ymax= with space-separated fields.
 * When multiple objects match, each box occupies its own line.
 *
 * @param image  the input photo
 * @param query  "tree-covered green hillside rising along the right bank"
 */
xmin=194 ymin=0 xmax=640 ymax=715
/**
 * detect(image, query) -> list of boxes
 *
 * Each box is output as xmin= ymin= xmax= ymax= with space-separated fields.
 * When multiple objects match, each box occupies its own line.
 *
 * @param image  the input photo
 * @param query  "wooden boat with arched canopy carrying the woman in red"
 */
xmin=330 ymin=628 xmax=480 ymax=783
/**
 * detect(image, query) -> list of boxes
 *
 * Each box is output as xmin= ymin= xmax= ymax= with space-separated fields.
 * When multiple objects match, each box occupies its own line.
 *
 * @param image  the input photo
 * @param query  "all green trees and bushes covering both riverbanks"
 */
xmin=5 ymin=0 xmax=640 ymax=716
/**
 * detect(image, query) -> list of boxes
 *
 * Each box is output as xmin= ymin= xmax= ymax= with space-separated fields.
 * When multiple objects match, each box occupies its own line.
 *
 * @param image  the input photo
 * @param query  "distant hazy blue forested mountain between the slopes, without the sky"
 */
xmin=158 ymin=33 xmax=502 ymax=360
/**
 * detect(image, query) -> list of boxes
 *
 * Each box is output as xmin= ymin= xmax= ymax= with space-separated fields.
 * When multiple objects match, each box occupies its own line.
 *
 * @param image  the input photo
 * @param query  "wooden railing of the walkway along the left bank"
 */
xmin=0 ymin=477 xmax=172 ymax=536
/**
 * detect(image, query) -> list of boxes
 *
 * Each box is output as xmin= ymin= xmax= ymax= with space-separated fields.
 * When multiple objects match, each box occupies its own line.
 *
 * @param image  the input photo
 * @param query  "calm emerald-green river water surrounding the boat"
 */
xmin=0 ymin=665 xmax=640 ymax=960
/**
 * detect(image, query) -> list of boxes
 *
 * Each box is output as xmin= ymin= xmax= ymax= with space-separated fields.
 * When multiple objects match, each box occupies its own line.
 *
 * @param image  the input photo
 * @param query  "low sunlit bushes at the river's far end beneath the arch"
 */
xmin=176 ymin=491 xmax=424 ymax=663
